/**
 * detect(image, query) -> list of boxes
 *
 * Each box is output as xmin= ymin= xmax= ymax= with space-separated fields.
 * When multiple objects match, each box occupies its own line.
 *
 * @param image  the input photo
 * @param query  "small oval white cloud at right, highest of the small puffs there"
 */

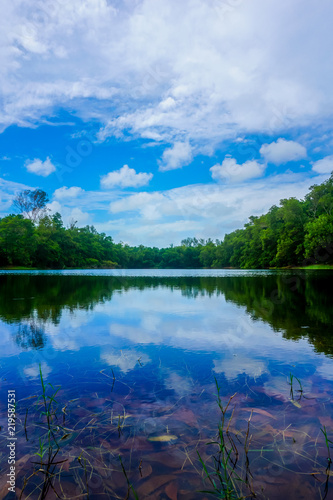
xmin=260 ymin=138 xmax=307 ymax=165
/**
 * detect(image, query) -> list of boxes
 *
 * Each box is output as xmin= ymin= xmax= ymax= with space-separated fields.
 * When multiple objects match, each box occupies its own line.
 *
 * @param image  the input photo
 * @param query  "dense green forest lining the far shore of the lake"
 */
xmin=0 ymin=174 xmax=333 ymax=269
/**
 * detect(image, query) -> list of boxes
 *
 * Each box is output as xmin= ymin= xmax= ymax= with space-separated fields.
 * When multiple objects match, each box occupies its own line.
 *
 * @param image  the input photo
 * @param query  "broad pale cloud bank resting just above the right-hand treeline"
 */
xmin=105 ymin=171 xmax=327 ymax=246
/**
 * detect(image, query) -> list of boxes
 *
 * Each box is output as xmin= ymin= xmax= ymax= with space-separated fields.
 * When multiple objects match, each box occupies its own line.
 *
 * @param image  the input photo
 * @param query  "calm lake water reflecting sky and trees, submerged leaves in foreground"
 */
xmin=0 ymin=270 xmax=333 ymax=500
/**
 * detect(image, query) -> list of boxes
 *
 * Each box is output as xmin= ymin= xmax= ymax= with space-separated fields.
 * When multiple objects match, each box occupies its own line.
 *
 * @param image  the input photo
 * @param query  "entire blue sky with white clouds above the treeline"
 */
xmin=0 ymin=0 xmax=333 ymax=246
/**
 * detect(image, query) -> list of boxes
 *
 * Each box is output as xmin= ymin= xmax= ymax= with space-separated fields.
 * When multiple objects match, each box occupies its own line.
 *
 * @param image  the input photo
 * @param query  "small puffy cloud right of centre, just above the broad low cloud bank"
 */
xmin=209 ymin=157 xmax=265 ymax=182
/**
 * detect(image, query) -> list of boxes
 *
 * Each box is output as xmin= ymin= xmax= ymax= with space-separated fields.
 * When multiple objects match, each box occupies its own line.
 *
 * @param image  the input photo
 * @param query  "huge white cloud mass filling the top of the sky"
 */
xmin=0 ymin=0 xmax=333 ymax=152
